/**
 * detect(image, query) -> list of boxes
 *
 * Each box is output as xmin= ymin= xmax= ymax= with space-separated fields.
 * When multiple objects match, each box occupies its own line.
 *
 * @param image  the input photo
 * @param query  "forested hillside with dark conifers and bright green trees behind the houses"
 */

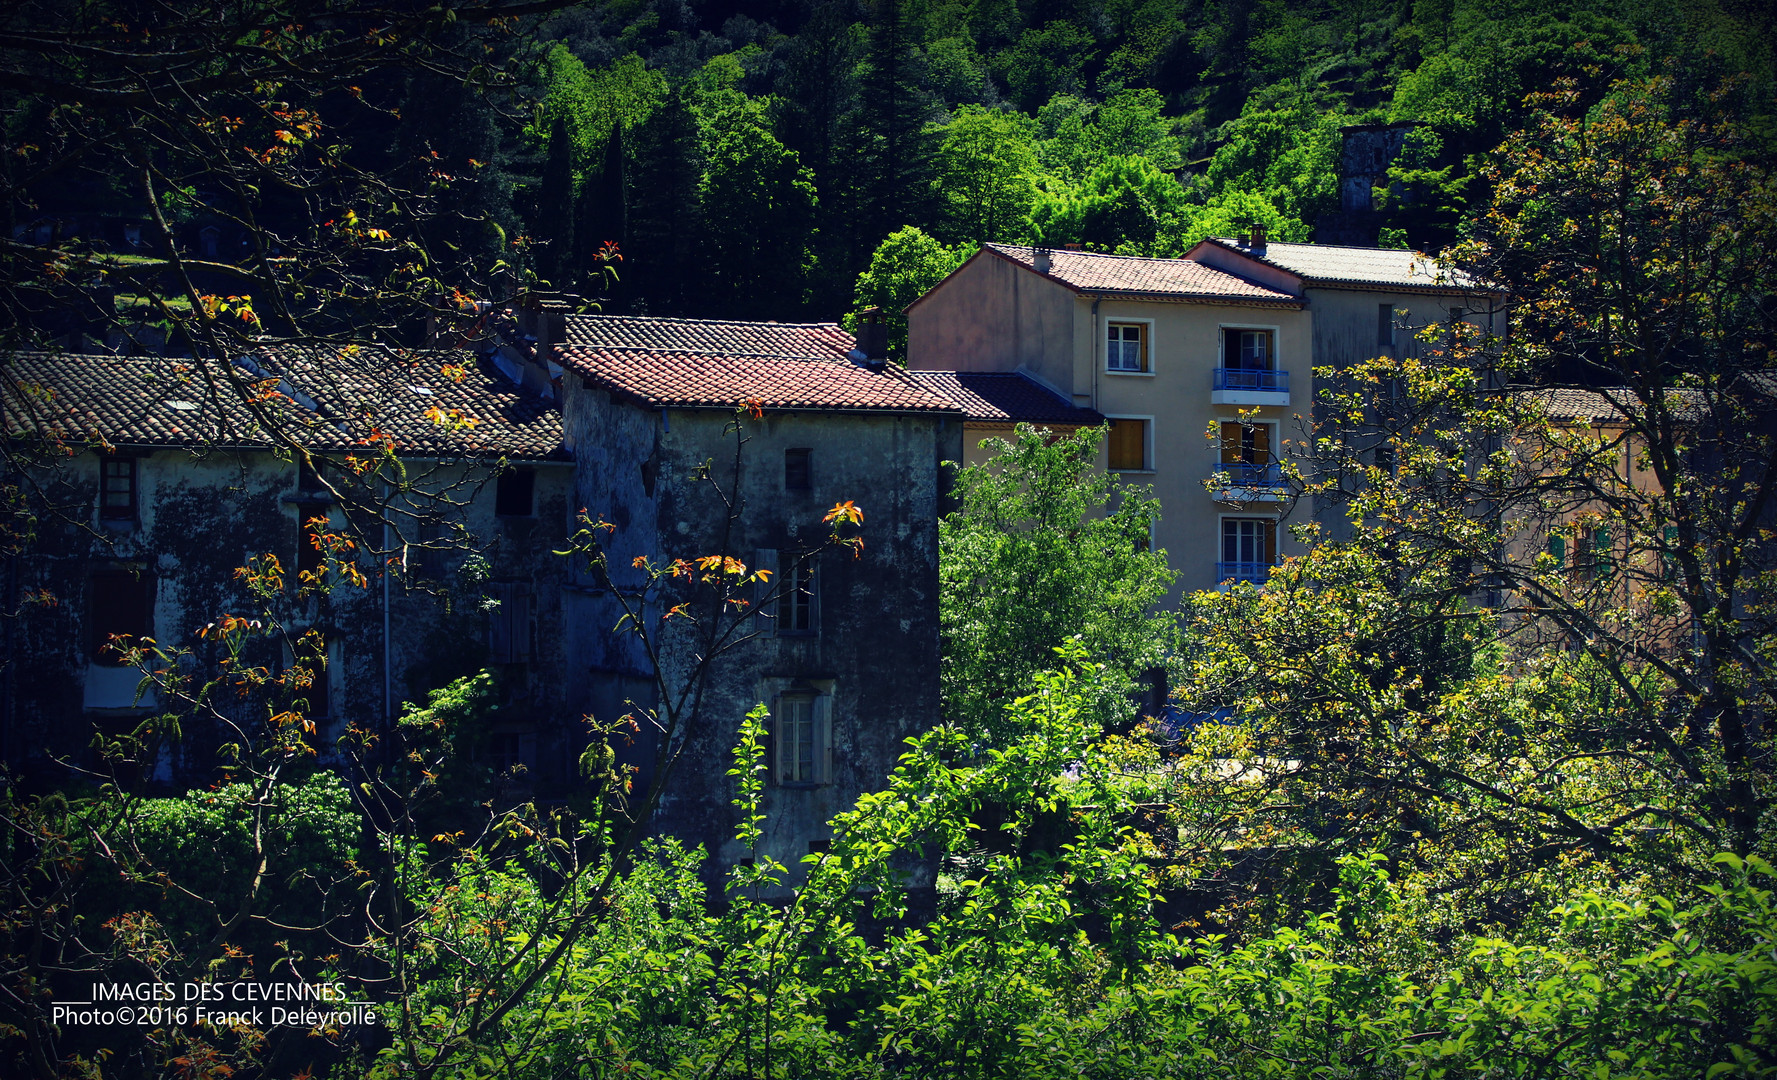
xmin=504 ymin=0 xmax=1772 ymax=318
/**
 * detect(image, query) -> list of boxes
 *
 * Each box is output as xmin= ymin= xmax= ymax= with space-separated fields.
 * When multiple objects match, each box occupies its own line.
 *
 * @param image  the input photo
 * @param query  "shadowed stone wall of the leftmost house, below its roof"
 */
xmin=0 ymin=449 xmax=572 ymax=785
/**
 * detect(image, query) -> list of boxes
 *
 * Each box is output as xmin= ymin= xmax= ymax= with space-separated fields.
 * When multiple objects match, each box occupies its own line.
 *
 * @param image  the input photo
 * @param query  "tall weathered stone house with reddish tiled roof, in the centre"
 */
xmin=538 ymin=316 xmax=963 ymax=876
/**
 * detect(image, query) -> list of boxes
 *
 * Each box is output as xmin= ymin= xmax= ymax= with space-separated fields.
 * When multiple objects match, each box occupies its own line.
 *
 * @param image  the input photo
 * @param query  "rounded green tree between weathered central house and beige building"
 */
xmin=938 ymin=426 xmax=1178 ymax=744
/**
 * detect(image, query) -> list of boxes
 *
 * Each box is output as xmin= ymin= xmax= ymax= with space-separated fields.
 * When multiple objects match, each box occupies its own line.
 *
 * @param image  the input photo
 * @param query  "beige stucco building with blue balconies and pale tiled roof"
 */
xmin=906 ymin=234 xmax=1494 ymax=593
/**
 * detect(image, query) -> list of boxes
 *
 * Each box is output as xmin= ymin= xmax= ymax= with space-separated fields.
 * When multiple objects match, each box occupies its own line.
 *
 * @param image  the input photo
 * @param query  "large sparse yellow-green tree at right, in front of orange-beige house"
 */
xmin=1185 ymin=78 xmax=1777 ymax=922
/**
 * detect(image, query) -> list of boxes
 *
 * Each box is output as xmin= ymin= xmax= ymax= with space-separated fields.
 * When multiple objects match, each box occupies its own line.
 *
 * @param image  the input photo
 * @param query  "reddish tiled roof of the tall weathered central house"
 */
xmin=556 ymin=314 xmax=958 ymax=412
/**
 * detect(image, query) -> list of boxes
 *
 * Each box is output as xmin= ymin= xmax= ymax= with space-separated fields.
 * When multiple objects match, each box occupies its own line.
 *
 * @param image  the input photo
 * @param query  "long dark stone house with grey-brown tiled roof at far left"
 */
xmin=0 ymin=352 xmax=572 ymax=785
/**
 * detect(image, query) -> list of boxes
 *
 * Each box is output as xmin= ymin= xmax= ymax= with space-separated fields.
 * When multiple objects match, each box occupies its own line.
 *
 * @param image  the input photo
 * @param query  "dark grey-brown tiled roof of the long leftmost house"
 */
xmin=0 ymin=350 xmax=565 ymax=460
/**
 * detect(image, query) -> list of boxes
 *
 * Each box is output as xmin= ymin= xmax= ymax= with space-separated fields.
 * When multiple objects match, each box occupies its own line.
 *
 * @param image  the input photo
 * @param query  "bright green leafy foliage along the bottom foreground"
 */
xmin=375 ymin=647 xmax=1777 ymax=1080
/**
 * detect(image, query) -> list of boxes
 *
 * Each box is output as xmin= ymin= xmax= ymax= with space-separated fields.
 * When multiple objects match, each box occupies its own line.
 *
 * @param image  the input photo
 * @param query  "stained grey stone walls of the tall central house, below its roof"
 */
xmin=565 ymin=380 xmax=961 ymax=891
